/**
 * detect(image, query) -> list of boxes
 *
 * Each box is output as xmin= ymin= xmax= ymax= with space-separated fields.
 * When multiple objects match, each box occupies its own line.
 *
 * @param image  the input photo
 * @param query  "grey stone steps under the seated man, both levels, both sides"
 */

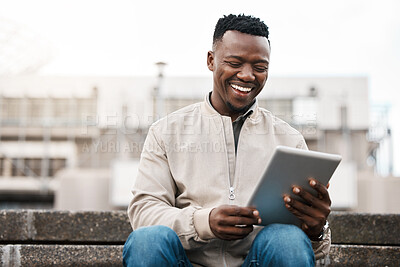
xmin=0 ymin=210 xmax=400 ymax=267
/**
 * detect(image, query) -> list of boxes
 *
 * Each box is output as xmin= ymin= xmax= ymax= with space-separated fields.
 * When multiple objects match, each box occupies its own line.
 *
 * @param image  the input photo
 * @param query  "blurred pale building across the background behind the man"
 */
xmin=0 ymin=75 xmax=397 ymax=214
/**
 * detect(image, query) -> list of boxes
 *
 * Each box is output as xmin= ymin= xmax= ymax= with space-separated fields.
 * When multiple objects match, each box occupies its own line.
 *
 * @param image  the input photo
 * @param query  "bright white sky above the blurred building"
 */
xmin=0 ymin=0 xmax=400 ymax=175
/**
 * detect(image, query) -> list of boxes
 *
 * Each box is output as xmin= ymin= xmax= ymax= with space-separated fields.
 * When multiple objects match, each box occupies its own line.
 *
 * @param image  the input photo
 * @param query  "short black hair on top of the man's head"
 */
xmin=213 ymin=14 xmax=269 ymax=45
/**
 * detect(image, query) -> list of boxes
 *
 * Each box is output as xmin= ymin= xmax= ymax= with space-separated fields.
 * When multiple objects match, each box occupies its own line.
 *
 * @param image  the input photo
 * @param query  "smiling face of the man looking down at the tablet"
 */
xmin=207 ymin=31 xmax=270 ymax=120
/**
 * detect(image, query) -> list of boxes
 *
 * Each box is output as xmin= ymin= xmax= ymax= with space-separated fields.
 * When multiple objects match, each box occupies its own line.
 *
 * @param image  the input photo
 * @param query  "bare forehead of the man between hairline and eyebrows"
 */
xmin=215 ymin=31 xmax=270 ymax=59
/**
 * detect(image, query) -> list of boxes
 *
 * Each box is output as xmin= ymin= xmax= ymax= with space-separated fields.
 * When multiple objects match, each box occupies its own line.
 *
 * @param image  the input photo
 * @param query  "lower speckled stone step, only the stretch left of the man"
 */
xmin=0 ymin=245 xmax=123 ymax=267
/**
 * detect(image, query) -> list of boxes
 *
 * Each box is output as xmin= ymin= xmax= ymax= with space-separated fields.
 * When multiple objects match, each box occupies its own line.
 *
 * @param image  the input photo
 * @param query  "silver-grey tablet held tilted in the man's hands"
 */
xmin=247 ymin=146 xmax=342 ymax=226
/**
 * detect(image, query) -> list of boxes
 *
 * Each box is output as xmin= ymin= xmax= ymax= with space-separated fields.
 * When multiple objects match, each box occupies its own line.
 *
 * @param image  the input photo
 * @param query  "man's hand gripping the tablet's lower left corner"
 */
xmin=209 ymin=205 xmax=261 ymax=240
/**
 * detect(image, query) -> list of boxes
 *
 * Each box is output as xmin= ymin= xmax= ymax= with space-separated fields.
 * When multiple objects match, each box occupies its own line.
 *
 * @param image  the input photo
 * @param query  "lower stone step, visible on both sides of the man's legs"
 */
xmin=0 ymin=245 xmax=400 ymax=267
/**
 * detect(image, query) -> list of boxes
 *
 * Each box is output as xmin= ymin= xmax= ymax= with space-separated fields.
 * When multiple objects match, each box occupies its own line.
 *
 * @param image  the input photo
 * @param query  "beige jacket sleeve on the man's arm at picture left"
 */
xmin=128 ymin=125 xmax=208 ymax=249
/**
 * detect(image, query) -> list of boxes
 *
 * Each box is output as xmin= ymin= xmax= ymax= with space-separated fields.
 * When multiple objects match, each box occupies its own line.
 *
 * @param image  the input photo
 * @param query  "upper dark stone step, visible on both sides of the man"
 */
xmin=0 ymin=210 xmax=400 ymax=246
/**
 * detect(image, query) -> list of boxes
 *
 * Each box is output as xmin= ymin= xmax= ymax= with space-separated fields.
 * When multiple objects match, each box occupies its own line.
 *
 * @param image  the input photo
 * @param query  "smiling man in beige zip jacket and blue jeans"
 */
xmin=123 ymin=15 xmax=330 ymax=266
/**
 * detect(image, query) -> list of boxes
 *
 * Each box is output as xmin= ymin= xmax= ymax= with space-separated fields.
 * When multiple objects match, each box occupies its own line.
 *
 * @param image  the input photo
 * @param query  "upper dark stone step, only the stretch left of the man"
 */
xmin=0 ymin=210 xmax=132 ymax=244
